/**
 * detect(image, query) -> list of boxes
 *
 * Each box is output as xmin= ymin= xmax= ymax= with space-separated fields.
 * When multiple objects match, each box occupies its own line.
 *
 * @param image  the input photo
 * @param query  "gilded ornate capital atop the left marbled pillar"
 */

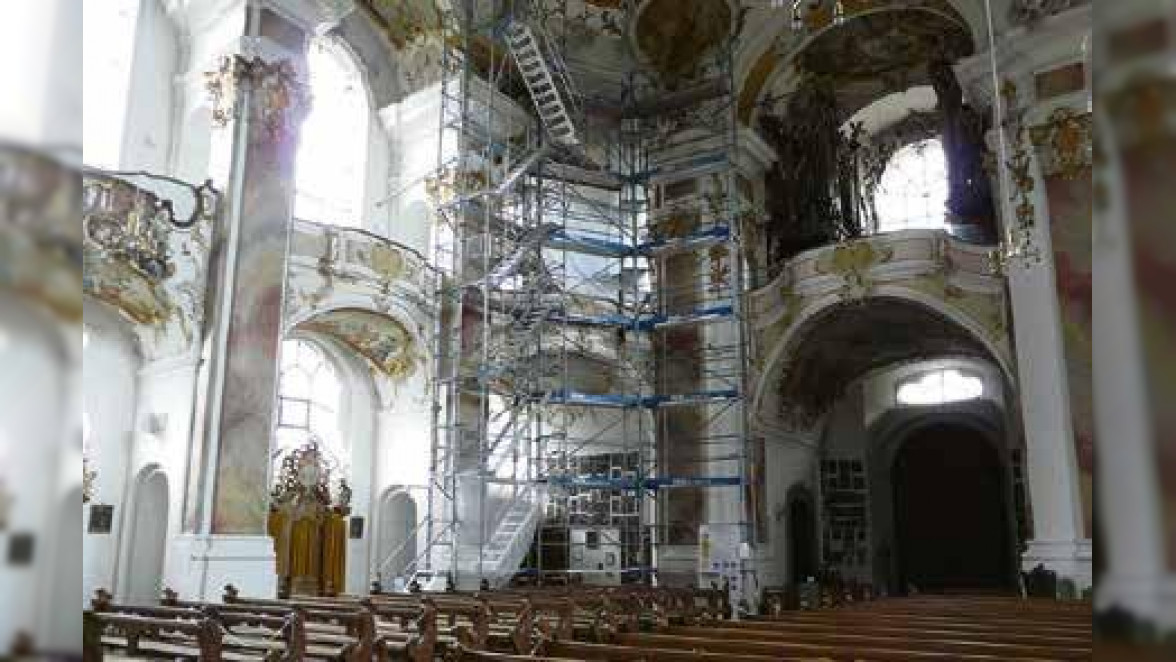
xmin=205 ymin=55 xmax=310 ymax=143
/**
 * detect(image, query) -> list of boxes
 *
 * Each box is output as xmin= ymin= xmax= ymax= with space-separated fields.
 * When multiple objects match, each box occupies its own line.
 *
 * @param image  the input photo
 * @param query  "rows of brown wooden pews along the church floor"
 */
xmin=86 ymin=586 xmax=1094 ymax=662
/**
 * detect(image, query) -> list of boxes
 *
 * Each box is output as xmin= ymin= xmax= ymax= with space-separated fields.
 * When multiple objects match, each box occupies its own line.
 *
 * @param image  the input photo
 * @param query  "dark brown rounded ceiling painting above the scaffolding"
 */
xmin=634 ymin=0 xmax=731 ymax=83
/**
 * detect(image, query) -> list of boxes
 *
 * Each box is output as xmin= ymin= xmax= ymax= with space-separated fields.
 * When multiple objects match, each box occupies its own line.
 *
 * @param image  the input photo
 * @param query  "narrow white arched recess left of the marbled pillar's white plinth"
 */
xmin=126 ymin=469 xmax=168 ymax=604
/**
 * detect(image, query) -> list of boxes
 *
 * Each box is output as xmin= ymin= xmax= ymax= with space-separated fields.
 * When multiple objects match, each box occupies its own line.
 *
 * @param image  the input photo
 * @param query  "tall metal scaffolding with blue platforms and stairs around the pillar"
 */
xmin=414 ymin=0 xmax=754 ymax=588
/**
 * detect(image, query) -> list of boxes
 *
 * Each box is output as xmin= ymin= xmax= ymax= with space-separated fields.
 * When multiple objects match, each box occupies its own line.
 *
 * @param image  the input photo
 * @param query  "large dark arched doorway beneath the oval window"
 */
xmin=891 ymin=423 xmax=1013 ymax=593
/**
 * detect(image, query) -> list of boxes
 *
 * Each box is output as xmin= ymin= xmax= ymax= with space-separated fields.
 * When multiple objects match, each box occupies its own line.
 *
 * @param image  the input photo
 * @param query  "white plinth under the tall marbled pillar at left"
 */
xmin=165 ymin=534 xmax=278 ymax=602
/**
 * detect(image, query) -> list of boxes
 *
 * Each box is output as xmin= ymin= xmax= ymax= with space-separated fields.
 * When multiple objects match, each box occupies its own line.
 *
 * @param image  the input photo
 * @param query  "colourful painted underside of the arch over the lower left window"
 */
xmin=296 ymin=309 xmax=422 ymax=380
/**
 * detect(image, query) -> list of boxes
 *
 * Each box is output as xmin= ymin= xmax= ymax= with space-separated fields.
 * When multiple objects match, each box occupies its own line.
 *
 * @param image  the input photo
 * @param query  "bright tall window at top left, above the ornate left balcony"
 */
xmin=81 ymin=0 xmax=140 ymax=169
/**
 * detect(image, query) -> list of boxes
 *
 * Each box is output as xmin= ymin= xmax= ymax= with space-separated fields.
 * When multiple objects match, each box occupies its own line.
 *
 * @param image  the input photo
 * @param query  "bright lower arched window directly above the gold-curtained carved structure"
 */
xmin=274 ymin=340 xmax=350 ymax=476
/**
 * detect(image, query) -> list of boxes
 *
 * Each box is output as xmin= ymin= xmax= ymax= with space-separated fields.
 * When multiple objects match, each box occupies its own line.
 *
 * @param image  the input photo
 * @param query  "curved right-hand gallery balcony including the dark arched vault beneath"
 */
xmin=748 ymin=230 xmax=1011 ymax=429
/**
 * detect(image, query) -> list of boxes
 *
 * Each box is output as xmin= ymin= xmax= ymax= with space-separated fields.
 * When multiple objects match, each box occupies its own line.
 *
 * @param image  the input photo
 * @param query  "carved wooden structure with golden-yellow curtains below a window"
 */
xmin=268 ymin=441 xmax=352 ymax=597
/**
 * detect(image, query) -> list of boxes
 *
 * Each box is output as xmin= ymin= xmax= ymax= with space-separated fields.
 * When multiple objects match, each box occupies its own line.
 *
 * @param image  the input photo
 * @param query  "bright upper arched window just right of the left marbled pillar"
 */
xmin=294 ymin=38 xmax=372 ymax=227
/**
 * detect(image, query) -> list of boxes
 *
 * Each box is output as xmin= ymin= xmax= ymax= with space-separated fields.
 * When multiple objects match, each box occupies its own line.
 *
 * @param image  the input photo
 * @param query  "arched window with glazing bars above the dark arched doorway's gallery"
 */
xmin=874 ymin=138 xmax=948 ymax=232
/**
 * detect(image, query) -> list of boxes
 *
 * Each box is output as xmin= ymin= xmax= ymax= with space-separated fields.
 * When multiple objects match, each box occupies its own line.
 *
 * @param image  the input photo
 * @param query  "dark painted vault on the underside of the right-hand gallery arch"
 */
xmin=770 ymin=297 xmax=995 ymax=424
